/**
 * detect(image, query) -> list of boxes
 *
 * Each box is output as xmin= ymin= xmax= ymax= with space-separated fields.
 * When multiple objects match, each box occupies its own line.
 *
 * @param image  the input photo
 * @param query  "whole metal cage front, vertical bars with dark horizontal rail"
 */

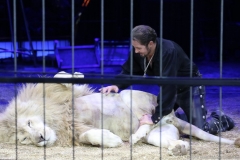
xmin=0 ymin=0 xmax=240 ymax=159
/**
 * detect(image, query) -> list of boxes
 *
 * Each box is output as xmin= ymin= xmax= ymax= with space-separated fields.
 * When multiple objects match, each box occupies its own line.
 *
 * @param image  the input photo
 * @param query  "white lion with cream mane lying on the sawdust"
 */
xmin=0 ymin=72 xmax=240 ymax=155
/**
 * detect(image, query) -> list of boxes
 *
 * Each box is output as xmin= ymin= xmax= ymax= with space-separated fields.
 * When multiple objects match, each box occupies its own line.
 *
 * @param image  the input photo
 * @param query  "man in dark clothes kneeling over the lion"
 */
xmin=100 ymin=25 xmax=234 ymax=134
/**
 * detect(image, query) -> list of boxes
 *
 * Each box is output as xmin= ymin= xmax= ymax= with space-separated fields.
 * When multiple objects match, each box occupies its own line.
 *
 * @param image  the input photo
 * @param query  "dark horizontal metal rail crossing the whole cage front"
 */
xmin=0 ymin=76 xmax=240 ymax=86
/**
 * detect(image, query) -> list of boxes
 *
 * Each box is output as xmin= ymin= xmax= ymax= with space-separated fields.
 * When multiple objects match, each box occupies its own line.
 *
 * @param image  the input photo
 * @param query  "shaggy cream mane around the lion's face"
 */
xmin=0 ymin=83 xmax=94 ymax=146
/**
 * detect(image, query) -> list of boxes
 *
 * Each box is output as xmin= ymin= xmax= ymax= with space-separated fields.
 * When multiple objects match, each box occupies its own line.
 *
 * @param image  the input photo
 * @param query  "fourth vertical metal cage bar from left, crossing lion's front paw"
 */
xmin=101 ymin=0 xmax=104 ymax=159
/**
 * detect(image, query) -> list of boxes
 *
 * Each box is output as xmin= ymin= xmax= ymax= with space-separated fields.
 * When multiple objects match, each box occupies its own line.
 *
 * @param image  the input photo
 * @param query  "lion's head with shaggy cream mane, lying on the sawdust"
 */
xmin=0 ymin=83 xmax=93 ymax=146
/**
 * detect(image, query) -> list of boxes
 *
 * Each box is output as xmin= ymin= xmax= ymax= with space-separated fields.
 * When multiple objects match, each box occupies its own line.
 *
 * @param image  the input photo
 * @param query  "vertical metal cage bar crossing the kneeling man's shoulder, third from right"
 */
xmin=159 ymin=0 xmax=163 ymax=159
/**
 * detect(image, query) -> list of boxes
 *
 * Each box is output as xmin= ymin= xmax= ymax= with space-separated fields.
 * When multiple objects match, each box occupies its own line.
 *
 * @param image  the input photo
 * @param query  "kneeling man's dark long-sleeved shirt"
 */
xmin=117 ymin=39 xmax=198 ymax=123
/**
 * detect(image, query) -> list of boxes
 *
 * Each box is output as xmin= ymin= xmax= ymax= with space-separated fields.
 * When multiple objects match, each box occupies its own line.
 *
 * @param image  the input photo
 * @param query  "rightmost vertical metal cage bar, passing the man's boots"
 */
xmin=219 ymin=0 xmax=224 ymax=159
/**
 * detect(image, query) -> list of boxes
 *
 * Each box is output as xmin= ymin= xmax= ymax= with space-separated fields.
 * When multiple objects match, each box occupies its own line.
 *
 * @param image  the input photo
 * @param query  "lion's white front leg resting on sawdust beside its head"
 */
xmin=79 ymin=129 xmax=123 ymax=147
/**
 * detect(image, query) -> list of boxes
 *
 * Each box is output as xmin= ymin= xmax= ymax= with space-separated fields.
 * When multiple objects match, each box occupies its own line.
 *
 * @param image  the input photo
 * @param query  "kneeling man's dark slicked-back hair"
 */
xmin=132 ymin=25 xmax=157 ymax=46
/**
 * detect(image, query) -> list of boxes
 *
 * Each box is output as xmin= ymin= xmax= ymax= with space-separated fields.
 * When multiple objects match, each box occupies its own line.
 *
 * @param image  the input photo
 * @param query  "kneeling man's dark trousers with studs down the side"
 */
xmin=174 ymin=86 xmax=207 ymax=130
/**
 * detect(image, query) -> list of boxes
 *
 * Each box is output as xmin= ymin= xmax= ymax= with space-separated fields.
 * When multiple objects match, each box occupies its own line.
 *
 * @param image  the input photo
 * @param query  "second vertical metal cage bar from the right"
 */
xmin=189 ymin=0 xmax=194 ymax=159
